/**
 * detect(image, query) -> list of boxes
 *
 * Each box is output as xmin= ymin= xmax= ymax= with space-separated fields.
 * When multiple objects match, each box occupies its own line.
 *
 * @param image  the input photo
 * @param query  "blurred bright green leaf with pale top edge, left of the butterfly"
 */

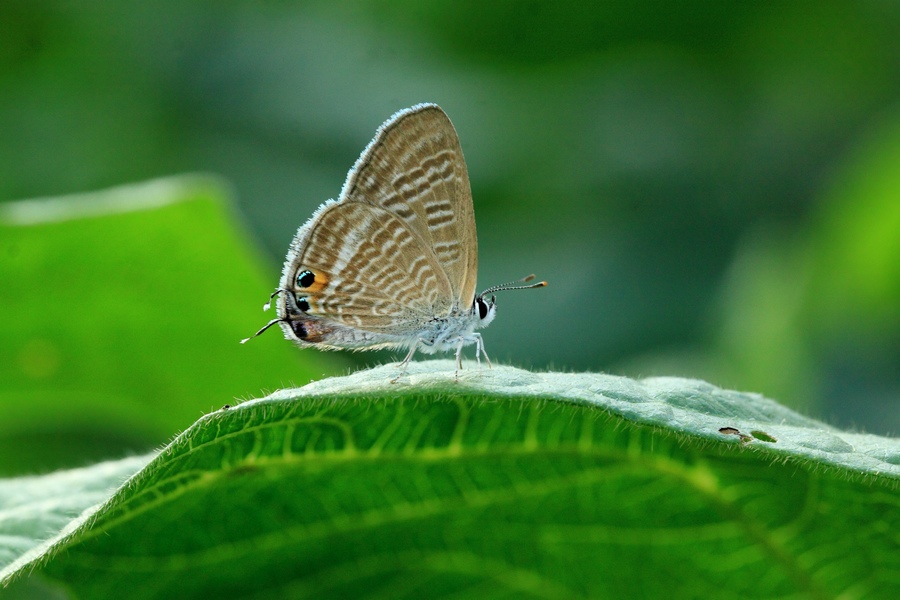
xmin=0 ymin=176 xmax=339 ymax=474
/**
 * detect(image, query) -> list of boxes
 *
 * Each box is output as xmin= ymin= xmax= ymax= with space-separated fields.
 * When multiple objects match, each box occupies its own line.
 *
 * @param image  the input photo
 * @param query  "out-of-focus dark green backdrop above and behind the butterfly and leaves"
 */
xmin=0 ymin=0 xmax=900 ymax=464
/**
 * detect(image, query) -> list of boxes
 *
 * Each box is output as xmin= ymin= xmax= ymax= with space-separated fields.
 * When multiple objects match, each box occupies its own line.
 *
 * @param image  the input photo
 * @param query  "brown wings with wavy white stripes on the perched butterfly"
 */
xmin=284 ymin=105 xmax=478 ymax=336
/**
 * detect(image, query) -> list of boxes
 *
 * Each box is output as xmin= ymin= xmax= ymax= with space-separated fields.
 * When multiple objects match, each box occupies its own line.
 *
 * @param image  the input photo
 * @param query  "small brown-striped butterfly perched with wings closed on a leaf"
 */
xmin=241 ymin=104 xmax=547 ymax=381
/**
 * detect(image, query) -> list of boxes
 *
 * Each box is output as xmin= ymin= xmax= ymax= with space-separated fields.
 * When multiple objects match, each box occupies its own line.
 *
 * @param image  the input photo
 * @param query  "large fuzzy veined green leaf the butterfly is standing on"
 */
xmin=0 ymin=361 xmax=900 ymax=598
